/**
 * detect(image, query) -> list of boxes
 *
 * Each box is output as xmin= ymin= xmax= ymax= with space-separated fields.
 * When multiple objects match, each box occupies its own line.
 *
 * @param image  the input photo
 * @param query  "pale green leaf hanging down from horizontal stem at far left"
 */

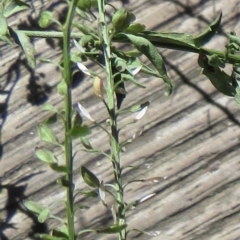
xmin=15 ymin=31 xmax=36 ymax=68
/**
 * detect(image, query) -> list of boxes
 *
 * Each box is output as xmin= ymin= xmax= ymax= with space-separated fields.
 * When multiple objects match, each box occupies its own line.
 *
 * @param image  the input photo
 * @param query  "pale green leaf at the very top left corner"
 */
xmin=4 ymin=0 xmax=31 ymax=18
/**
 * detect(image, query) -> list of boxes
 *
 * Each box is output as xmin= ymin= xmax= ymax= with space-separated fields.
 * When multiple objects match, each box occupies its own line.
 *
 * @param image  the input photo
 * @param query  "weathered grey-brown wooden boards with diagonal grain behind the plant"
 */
xmin=0 ymin=0 xmax=240 ymax=240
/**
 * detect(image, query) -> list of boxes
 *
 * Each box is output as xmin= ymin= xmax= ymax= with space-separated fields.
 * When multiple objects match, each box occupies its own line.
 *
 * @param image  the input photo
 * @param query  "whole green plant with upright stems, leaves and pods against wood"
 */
xmin=0 ymin=0 xmax=240 ymax=240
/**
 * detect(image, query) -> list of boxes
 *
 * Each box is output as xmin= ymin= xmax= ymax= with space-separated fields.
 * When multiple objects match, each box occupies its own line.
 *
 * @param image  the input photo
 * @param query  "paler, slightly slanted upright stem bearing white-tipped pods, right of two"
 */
xmin=98 ymin=0 xmax=126 ymax=240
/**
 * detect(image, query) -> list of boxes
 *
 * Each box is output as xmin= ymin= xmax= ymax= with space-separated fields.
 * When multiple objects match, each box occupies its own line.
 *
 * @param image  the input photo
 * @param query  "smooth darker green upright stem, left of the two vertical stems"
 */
xmin=63 ymin=0 xmax=77 ymax=240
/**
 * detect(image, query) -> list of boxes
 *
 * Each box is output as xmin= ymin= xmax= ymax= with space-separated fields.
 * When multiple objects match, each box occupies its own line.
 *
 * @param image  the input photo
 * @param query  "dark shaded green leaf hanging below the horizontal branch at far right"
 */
xmin=198 ymin=53 xmax=236 ymax=97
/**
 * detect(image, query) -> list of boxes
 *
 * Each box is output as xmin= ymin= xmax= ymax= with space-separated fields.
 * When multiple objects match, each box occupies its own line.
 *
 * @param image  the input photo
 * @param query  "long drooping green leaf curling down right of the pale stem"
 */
xmin=122 ymin=34 xmax=172 ymax=94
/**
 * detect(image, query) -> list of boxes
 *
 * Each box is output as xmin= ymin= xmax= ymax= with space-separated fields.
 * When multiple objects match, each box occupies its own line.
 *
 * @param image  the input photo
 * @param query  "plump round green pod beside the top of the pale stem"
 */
xmin=112 ymin=8 xmax=135 ymax=32
